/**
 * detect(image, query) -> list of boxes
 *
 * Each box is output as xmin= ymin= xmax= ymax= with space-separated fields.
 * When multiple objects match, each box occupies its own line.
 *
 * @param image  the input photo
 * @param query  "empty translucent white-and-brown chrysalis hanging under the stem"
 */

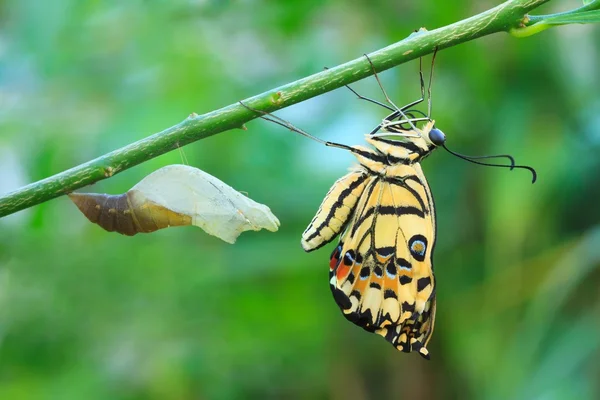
xmin=69 ymin=165 xmax=279 ymax=243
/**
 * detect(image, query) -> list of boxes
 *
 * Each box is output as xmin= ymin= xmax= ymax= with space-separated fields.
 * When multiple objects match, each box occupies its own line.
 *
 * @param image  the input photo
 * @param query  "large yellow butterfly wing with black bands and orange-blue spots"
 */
xmin=330 ymin=164 xmax=435 ymax=358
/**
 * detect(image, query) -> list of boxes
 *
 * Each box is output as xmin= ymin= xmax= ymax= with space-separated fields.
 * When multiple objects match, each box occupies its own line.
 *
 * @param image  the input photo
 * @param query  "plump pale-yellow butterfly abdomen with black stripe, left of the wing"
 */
xmin=302 ymin=166 xmax=373 ymax=252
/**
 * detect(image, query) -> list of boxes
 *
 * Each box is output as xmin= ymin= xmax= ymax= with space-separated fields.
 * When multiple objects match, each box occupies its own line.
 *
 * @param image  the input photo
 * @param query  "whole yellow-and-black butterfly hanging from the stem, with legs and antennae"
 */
xmin=241 ymin=52 xmax=536 ymax=359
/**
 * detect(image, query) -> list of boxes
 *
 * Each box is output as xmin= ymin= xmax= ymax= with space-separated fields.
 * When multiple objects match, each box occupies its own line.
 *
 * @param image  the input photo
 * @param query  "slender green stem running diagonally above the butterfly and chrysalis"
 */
xmin=0 ymin=0 xmax=549 ymax=217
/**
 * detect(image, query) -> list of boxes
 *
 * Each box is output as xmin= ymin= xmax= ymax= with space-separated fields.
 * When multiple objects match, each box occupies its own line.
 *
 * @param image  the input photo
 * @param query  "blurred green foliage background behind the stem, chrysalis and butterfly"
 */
xmin=0 ymin=0 xmax=600 ymax=399
